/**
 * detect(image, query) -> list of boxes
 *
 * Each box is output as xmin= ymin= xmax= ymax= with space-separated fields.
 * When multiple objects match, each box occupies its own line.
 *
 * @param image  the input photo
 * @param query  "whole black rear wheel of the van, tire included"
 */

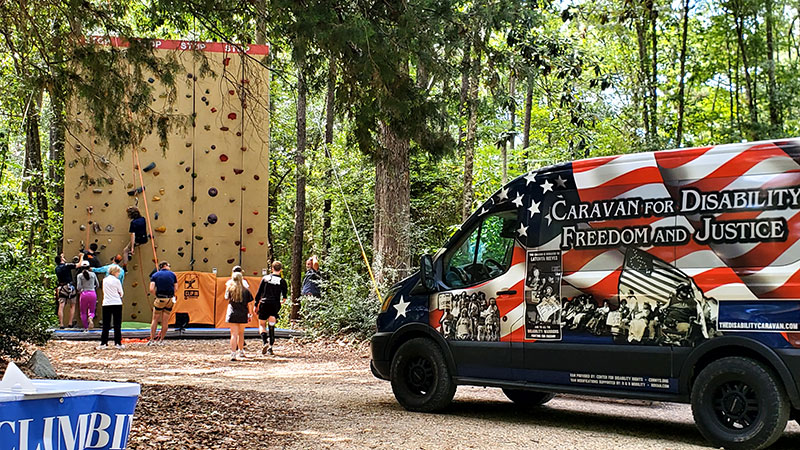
xmin=692 ymin=357 xmax=790 ymax=449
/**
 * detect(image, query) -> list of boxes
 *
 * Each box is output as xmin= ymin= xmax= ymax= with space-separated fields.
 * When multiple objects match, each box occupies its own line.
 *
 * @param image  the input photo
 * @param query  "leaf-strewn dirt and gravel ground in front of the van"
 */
xmin=40 ymin=339 xmax=800 ymax=449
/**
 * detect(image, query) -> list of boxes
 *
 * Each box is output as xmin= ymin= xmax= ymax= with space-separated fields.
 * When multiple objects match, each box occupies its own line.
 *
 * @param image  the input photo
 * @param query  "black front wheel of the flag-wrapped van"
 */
xmin=391 ymin=338 xmax=456 ymax=412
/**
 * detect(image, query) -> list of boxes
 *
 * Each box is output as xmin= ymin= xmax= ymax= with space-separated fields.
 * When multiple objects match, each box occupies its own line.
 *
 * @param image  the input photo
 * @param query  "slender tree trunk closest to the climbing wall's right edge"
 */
xmin=289 ymin=57 xmax=307 ymax=321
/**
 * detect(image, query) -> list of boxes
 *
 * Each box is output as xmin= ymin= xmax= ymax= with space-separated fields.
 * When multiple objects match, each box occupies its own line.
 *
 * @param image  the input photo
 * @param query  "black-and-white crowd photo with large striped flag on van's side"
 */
xmin=562 ymin=247 xmax=720 ymax=346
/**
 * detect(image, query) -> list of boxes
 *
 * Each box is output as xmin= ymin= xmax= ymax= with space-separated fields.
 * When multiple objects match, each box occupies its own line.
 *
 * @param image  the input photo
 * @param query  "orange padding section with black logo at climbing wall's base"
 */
xmin=170 ymin=272 xmax=217 ymax=325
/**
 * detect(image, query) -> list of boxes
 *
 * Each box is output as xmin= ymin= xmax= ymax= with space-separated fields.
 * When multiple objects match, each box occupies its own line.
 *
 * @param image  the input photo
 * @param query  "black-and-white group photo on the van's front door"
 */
xmin=437 ymin=291 xmax=500 ymax=341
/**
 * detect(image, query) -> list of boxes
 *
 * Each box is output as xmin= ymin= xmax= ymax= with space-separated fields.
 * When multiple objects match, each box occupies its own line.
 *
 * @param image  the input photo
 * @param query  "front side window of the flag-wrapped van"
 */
xmin=443 ymin=211 xmax=517 ymax=288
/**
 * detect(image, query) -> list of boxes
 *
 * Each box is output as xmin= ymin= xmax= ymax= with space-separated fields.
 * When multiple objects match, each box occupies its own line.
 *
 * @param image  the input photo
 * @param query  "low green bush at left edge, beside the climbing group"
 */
xmin=0 ymin=265 xmax=55 ymax=359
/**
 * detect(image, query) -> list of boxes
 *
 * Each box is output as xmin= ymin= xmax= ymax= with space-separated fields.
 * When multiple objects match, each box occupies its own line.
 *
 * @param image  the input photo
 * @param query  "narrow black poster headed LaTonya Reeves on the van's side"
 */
xmin=525 ymin=250 xmax=561 ymax=341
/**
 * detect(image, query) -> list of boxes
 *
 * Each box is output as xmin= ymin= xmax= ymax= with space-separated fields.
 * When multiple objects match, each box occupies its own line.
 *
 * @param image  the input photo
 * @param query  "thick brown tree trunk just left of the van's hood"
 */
xmin=373 ymin=122 xmax=411 ymax=284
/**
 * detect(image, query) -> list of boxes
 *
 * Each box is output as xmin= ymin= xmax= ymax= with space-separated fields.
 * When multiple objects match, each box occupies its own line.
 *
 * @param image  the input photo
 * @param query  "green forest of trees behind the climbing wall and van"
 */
xmin=0 ymin=0 xmax=800 ymax=356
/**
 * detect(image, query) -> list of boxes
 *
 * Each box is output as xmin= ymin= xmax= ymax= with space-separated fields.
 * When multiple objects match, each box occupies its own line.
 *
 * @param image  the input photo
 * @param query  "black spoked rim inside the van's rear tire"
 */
xmin=713 ymin=381 xmax=760 ymax=431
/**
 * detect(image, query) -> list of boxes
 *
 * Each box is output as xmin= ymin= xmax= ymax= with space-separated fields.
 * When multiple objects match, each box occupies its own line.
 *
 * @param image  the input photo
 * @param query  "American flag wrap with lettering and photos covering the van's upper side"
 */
xmin=427 ymin=140 xmax=800 ymax=347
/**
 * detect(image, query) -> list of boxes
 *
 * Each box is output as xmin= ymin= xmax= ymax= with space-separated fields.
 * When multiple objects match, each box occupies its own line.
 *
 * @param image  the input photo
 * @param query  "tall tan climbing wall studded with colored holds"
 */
xmin=64 ymin=40 xmax=269 ymax=321
